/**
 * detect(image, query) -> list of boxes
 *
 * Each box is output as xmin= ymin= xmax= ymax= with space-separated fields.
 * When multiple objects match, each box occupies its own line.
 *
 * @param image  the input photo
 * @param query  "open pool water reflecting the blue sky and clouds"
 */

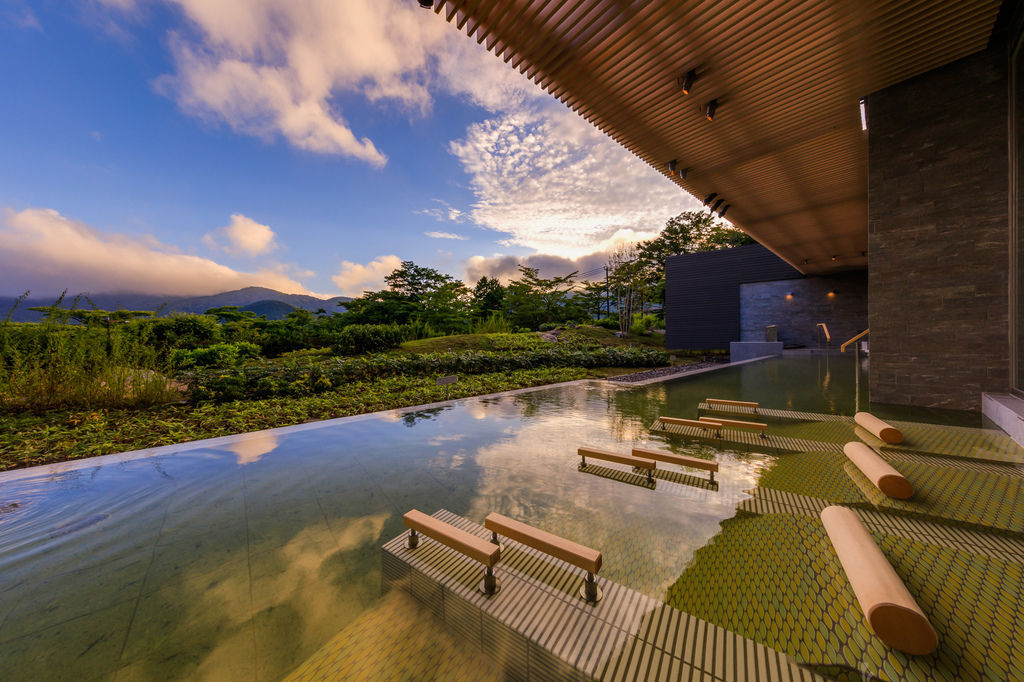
xmin=0 ymin=356 xmax=1024 ymax=680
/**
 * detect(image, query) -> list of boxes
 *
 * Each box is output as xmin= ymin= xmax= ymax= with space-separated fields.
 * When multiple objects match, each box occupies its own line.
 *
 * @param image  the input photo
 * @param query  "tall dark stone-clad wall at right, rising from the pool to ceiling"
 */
xmin=867 ymin=47 xmax=1009 ymax=410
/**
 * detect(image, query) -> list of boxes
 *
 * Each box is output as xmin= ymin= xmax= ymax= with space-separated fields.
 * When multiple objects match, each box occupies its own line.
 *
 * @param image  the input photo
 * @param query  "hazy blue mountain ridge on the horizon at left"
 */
xmin=0 ymin=287 xmax=352 ymax=322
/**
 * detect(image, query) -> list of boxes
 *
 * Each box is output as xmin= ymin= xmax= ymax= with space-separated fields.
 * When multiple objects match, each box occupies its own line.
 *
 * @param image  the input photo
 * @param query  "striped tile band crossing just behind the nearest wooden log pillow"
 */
xmin=739 ymin=487 xmax=1024 ymax=563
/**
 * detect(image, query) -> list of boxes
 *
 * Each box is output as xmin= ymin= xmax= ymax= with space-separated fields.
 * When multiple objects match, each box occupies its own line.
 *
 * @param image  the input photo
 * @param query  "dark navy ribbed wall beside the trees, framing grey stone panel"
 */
xmin=665 ymin=244 xmax=800 ymax=350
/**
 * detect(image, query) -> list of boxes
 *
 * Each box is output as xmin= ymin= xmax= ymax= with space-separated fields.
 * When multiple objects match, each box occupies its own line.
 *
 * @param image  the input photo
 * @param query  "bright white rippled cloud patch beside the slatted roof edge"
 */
xmin=451 ymin=104 xmax=699 ymax=258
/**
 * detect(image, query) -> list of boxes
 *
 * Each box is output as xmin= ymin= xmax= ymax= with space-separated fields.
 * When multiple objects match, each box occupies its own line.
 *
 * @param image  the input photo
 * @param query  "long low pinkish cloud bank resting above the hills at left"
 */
xmin=0 ymin=208 xmax=309 ymax=296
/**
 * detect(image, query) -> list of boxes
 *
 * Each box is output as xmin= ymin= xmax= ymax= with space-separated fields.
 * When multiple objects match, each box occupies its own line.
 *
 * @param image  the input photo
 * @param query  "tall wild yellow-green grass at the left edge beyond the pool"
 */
xmin=0 ymin=296 xmax=182 ymax=412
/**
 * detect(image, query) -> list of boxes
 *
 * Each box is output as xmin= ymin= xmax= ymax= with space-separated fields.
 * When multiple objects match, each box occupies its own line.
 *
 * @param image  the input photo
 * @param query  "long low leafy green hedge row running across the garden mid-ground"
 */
xmin=183 ymin=346 xmax=669 ymax=402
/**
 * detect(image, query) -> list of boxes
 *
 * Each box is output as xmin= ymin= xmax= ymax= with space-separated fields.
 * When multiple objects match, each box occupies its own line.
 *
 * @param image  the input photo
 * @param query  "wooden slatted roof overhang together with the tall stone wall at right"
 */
xmin=433 ymin=0 xmax=1024 ymax=415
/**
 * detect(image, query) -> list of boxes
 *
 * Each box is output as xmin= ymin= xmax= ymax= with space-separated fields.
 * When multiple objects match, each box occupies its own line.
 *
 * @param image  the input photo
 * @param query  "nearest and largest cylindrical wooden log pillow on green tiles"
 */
xmin=821 ymin=506 xmax=939 ymax=655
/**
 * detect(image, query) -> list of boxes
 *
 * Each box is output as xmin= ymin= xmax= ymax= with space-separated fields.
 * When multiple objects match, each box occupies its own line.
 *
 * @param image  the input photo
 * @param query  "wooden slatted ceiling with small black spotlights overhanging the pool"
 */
xmin=435 ymin=0 xmax=1000 ymax=273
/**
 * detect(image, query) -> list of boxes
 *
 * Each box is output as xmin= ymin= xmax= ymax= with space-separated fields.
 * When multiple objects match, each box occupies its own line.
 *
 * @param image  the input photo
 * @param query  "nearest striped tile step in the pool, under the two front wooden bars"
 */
xmin=382 ymin=510 xmax=821 ymax=680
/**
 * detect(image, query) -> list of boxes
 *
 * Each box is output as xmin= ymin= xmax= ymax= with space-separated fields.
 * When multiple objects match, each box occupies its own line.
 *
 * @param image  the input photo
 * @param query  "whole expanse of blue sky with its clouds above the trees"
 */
xmin=0 ymin=0 xmax=696 ymax=295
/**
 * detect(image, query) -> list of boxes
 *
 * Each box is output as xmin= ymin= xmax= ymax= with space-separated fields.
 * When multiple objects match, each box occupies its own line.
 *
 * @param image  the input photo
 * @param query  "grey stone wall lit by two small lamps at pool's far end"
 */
xmin=739 ymin=270 xmax=867 ymax=348
